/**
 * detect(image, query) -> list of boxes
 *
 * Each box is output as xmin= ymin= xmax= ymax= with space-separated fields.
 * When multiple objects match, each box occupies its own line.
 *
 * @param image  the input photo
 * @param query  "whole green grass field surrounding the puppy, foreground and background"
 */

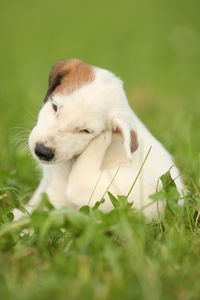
xmin=0 ymin=0 xmax=200 ymax=300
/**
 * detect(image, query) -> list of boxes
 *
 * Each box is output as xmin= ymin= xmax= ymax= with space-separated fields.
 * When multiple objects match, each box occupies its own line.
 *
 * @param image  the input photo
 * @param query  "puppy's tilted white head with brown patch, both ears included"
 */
xmin=29 ymin=59 xmax=138 ymax=163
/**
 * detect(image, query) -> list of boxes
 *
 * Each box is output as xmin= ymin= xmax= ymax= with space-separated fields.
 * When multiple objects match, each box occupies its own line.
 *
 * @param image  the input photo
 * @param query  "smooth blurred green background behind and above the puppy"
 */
xmin=0 ymin=0 xmax=200 ymax=188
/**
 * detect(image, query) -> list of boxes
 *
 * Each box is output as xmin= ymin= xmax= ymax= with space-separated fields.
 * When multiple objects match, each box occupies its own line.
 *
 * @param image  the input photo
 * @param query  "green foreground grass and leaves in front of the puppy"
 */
xmin=0 ymin=173 xmax=200 ymax=299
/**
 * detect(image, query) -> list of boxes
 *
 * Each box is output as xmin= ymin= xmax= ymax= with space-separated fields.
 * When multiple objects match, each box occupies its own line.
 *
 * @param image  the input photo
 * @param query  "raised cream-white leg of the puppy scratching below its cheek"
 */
xmin=66 ymin=131 xmax=112 ymax=207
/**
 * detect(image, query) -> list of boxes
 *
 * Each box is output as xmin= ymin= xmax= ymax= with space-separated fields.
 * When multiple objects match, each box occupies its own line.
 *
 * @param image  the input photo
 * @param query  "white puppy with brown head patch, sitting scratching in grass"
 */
xmin=14 ymin=59 xmax=182 ymax=218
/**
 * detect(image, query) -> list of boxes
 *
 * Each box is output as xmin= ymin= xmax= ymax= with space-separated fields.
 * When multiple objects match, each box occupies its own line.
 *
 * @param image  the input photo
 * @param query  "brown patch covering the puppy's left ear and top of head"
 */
xmin=44 ymin=58 xmax=95 ymax=102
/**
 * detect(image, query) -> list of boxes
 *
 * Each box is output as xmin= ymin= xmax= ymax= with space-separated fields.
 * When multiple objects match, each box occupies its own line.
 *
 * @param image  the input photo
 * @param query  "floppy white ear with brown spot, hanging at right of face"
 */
xmin=112 ymin=115 xmax=139 ymax=160
